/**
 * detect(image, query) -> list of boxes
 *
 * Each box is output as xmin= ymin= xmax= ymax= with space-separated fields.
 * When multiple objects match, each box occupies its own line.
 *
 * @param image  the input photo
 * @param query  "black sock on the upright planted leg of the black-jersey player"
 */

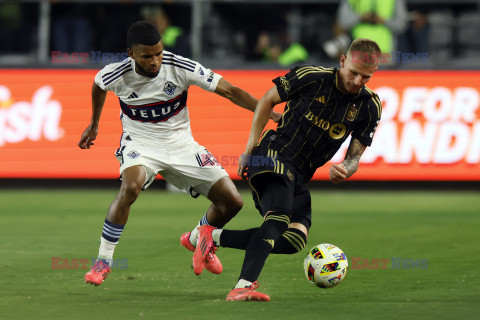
xmin=239 ymin=215 xmax=290 ymax=282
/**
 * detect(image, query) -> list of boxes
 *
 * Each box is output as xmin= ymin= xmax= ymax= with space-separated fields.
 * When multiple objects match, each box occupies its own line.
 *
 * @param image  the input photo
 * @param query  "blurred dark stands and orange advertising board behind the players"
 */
xmin=0 ymin=0 xmax=480 ymax=188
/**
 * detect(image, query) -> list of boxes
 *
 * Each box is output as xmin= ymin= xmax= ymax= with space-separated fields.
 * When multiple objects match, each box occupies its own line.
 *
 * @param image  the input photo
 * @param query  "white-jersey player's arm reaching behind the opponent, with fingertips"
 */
xmin=215 ymin=78 xmax=282 ymax=122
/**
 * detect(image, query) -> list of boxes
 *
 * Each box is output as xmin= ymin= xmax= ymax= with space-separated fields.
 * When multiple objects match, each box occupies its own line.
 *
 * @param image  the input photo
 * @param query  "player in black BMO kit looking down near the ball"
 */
xmin=193 ymin=39 xmax=382 ymax=301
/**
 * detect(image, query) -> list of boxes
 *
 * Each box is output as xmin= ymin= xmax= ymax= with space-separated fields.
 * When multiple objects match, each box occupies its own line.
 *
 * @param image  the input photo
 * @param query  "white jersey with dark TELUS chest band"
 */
xmin=95 ymin=50 xmax=221 ymax=149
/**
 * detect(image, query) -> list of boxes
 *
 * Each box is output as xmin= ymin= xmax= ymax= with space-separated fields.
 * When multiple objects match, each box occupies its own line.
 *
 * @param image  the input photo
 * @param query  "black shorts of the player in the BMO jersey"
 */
xmin=247 ymin=146 xmax=312 ymax=229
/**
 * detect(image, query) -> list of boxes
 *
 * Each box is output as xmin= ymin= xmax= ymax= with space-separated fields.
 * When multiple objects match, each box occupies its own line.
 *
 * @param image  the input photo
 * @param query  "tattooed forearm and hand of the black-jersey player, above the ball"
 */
xmin=330 ymin=138 xmax=367 ymax=183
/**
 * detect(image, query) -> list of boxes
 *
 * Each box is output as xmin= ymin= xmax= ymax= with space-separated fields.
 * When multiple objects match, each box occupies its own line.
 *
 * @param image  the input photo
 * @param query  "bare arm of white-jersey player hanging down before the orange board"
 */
xmin=78 ymin=82 xmax=107 ymax=149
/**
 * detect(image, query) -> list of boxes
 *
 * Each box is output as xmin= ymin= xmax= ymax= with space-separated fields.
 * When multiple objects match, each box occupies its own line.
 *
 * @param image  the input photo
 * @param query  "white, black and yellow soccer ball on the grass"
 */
xmin=303 ymin=243 xmax=348 ymax=288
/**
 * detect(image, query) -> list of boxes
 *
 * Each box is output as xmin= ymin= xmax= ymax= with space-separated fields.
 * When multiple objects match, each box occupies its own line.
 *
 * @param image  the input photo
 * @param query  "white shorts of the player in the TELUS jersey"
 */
xmin=115 ymin=133 xmax=228 ymax=197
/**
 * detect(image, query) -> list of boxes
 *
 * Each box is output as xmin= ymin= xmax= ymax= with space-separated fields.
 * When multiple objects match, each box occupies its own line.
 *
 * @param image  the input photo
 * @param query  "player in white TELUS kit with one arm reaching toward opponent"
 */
xmin=78 ymin=21 xmax=281 ymax=285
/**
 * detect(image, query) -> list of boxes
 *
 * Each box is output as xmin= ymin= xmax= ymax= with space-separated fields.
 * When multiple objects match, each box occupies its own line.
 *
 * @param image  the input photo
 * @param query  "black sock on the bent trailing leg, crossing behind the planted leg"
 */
xmin=220 ymin=228 xmax=307 ymax=254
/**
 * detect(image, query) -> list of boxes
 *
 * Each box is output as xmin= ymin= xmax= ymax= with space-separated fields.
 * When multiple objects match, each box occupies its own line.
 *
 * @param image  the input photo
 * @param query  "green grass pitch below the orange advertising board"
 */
xmin=0 ymin=190 xmax=480 ymax=320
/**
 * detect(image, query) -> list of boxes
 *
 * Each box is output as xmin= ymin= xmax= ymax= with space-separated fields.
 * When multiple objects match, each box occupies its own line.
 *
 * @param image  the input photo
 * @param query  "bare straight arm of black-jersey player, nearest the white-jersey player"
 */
xmin=238 ymin=86 xmax=282 ymax=179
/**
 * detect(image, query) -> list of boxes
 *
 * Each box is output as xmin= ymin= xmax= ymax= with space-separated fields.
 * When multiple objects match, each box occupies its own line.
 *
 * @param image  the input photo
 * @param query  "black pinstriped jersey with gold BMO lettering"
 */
xmin=260 ymin=66 xmax=382 ymax=180
